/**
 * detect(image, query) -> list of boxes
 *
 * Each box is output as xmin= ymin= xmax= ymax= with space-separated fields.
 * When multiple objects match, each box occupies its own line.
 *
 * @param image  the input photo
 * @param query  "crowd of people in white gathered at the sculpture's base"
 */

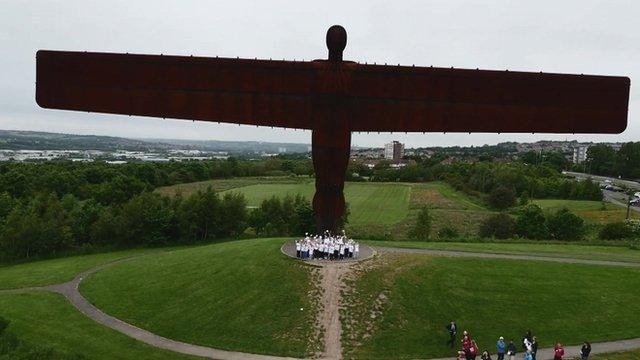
xmin=296 ymin=231 xmax=360 ymax=260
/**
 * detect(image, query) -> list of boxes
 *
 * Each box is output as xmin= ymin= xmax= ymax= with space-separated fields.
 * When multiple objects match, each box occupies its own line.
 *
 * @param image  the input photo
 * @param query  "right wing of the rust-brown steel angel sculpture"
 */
xmin=349 ymin=65 xmax=630 ymax=133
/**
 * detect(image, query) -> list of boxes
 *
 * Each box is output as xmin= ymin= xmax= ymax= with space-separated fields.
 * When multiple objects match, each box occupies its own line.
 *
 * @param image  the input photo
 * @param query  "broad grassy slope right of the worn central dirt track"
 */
xmin=343 ymin=255 xmax=640 ymax=359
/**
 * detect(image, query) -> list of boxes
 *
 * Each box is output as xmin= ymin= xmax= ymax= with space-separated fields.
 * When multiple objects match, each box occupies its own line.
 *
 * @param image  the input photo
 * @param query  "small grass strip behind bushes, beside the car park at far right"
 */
xmin=532 ymin=199 xmax=640 ymax=224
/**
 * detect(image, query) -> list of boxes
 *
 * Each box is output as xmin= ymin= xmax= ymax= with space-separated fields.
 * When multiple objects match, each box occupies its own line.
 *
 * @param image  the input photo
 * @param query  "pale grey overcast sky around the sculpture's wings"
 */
xmin=0 ymin=0 xmax=640 ymax=146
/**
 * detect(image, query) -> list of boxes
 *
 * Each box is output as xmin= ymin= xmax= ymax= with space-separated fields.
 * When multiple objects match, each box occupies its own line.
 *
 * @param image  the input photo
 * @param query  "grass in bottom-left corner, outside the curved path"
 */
xmin=0 ymin=292 xmax=196 ymax=360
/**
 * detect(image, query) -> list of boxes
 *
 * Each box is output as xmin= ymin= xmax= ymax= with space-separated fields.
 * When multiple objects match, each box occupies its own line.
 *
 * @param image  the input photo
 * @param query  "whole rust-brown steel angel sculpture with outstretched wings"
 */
xmin=36 ymin=26 xmax=630 ymax=231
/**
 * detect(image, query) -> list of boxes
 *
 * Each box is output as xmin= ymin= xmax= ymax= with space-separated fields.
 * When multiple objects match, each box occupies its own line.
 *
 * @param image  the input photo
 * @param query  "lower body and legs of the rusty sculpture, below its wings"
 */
xmin=312 ymin=128 xmax=351 ymax=233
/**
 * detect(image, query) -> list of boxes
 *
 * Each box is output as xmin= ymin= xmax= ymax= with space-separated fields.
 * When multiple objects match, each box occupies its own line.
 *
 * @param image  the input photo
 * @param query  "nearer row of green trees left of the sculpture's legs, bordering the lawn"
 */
xmin=0 ymin=188 xmax=330 ymax=262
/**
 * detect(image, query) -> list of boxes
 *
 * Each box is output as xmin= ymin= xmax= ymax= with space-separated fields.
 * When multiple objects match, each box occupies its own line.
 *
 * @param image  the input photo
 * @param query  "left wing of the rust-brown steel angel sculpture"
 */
xmin=36 ymin=50 xmax=314 ymax=129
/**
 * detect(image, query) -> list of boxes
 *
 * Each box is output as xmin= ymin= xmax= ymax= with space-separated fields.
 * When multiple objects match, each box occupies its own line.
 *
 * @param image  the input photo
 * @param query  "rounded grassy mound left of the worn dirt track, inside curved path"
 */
xmin=80 ymin=239 xmax=315 ymax=356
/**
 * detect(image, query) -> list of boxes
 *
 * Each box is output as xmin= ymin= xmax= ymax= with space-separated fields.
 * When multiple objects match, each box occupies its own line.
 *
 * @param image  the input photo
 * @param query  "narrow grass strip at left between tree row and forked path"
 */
xmin=0 ymin=249 xmax=154 ymax=289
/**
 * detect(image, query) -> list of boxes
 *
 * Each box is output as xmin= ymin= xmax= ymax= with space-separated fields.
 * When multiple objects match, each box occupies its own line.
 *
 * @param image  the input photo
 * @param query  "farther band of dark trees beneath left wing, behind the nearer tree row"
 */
xmin=0 ymin=157 xmax=313 ymax=205
